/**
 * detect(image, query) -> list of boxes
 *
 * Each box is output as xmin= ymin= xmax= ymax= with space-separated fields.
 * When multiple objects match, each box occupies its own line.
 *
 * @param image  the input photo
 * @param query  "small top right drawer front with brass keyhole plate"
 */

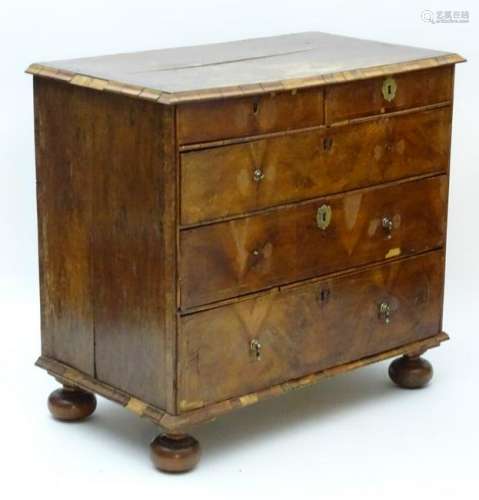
xmin=325 ymin=66 xmax=453 ymax=123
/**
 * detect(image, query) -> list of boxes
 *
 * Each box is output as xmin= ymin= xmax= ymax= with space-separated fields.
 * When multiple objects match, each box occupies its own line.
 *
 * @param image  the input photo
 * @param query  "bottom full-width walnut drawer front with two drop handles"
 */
xmin=178 ymin=251 xmax=444 ymax=411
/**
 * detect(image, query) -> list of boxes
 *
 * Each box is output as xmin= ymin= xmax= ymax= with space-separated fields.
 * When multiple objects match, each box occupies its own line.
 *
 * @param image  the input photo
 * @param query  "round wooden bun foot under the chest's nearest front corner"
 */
xmin=150 ymin=434 xmax=200 ymax=472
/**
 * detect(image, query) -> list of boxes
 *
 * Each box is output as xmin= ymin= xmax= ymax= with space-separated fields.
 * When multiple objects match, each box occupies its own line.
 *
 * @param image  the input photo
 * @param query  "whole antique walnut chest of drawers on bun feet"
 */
xmin=28 ymin=33 xmax=463 ymax=471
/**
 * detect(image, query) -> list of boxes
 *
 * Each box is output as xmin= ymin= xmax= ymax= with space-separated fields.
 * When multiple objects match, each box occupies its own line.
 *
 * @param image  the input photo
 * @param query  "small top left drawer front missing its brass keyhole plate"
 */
xmin=177 ymin=88 xmax=324 ymax=144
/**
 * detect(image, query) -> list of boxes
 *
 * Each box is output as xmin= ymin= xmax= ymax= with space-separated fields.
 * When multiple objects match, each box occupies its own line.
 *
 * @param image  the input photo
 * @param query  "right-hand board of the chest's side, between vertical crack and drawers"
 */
xmin=93 ymin=88 xmax=176 ymax=410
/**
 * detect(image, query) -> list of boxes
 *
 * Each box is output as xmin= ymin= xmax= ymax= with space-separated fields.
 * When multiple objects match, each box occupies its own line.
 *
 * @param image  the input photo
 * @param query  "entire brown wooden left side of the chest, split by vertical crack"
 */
xmin=35 ymin=79 xmax=176 ymax=409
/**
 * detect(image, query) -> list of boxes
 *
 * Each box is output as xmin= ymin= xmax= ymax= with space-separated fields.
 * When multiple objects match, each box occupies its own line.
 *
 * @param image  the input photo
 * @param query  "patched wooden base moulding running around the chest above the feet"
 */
xmin=36 ymin=332 xmax=449 ymax=431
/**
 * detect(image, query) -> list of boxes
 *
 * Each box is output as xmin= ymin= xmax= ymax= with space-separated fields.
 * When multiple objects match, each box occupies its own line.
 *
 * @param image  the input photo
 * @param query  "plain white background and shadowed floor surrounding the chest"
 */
xmin=0 ymin=0 xmax=479 ymax=500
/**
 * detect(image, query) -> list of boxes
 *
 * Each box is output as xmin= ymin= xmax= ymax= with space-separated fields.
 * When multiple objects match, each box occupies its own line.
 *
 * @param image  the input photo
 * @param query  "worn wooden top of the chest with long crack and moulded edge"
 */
xmin=27 ymin=32 xmax=464 ymax=104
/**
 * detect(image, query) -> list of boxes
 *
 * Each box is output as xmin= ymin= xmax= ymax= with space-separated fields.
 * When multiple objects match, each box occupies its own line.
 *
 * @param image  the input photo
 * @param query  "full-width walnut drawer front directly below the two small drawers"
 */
xmin=181 ymin=107 xmax=451 ymax=224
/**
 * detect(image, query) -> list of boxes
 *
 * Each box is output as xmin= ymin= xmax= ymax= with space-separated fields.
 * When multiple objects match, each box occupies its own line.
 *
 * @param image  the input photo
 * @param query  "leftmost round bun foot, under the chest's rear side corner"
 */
xmin=48 ymin=385 xmax=96 ymax=422
